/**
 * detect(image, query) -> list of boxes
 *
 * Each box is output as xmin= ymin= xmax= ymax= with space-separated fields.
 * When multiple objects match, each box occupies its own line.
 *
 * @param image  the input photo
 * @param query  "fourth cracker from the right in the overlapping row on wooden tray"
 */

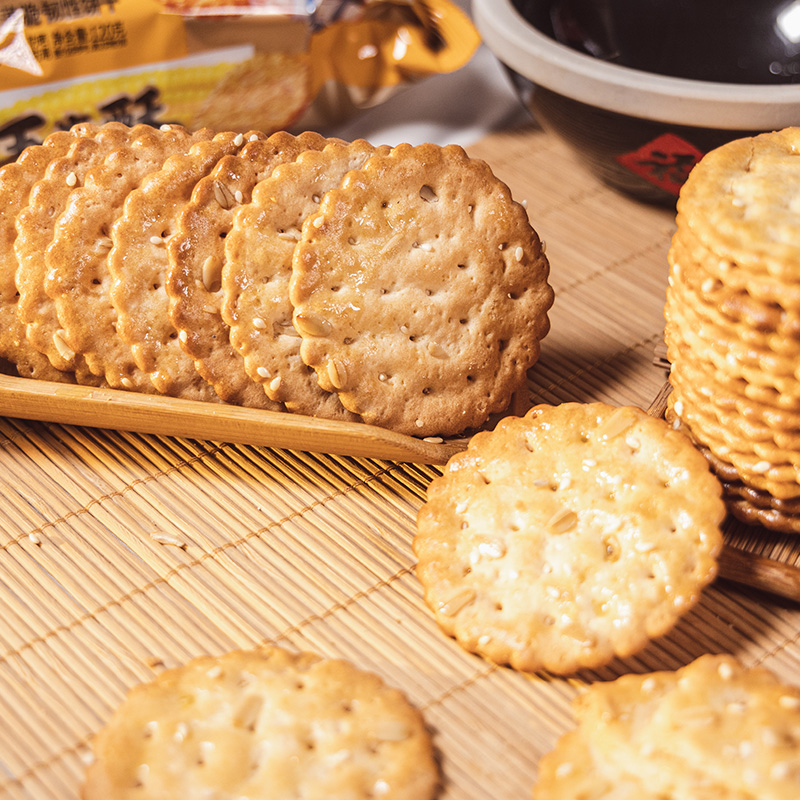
xmin=108 ymin=131 xmax=260 ymax=402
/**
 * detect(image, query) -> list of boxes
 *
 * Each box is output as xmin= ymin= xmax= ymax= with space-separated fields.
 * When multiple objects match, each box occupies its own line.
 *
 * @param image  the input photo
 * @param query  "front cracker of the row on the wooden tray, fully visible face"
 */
xmin=291 ymin=144 xmax=553 ymax=436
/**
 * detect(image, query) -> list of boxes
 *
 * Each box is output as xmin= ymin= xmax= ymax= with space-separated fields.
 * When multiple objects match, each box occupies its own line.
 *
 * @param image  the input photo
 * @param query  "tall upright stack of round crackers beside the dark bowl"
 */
xmin=665 ymin=128 xmax=800 ymax=533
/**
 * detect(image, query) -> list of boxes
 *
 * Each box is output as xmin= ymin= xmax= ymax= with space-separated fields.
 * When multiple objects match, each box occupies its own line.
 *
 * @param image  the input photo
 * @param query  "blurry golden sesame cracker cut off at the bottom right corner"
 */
xmin=533 ymin=655 xmax=800 ymax=800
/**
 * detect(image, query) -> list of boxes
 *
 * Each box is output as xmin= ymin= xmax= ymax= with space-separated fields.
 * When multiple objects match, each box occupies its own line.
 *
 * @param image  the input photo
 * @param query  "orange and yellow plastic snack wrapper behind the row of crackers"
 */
xmin=0 ymin=0 xmax=480 ymax=163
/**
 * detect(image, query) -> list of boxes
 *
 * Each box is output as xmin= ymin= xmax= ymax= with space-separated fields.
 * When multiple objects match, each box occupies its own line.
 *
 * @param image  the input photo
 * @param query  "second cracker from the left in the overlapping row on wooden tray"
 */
xmin=14 ymin=122 xmax=131 ymax=385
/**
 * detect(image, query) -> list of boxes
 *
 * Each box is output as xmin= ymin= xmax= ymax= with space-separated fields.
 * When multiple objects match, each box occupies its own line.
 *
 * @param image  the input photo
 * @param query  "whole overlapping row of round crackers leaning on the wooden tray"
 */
xmin=0 ymin=123 xmax=553 ymax=437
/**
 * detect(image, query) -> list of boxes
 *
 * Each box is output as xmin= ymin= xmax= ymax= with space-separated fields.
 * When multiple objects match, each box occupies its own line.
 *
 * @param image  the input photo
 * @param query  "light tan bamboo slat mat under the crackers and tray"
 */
xmin=0 ymin=128 xmax=800 ymax=800
